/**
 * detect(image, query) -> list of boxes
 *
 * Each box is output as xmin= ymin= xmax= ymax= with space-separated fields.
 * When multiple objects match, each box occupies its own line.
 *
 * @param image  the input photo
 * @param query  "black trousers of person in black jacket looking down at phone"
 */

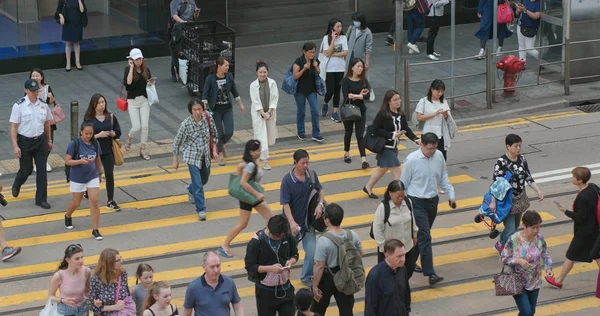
xmin=254 ymin=284 xmax=296 ymax=316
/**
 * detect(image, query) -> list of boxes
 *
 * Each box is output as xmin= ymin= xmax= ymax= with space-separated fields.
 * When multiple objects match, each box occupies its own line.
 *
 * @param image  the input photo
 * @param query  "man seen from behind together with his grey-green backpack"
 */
xmin=312 ymin=203 xmax=365 ymax=316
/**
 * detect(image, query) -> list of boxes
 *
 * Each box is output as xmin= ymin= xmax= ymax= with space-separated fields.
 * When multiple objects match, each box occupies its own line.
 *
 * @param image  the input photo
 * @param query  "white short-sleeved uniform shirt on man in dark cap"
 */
xmin=10 ymin=97 xmax=52 ymax=137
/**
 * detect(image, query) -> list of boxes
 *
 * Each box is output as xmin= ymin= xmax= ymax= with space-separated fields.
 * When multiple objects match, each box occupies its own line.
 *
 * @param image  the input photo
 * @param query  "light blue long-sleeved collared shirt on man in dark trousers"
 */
xmin=400 ymin=149 xmax=455 ymax=200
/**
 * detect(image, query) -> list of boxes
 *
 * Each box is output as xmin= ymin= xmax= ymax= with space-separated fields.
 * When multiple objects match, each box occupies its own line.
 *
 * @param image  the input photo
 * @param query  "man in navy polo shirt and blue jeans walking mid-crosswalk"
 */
xmin=279 ymin=149 xmax=325 ymax=288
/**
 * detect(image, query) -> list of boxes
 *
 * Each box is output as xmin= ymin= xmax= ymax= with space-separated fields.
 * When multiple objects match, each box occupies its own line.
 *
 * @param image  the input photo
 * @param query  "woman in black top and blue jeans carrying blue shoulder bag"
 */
xmin=293 ymin=43 xmax=324 ymax=143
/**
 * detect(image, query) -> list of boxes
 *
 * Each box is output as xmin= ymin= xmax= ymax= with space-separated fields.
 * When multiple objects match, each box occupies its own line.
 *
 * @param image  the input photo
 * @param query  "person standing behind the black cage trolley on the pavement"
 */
xmin=167 ymin=0 xmax=200 ymax=82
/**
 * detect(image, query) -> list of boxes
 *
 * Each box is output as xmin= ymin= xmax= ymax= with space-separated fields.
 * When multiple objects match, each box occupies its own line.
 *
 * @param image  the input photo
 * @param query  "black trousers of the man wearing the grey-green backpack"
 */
xmin=312 ymin=269 xmax=354 ymax=316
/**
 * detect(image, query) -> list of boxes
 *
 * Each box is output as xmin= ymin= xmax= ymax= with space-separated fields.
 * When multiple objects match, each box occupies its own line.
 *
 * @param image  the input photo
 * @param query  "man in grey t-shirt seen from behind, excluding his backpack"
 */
xmin=313 ymin=203 xmax=364 ymax=316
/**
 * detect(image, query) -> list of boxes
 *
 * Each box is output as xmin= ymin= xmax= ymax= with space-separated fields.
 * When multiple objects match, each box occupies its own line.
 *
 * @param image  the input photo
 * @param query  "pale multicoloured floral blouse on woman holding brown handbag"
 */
xmin=500 ymin=233 xmax=552 ymax=291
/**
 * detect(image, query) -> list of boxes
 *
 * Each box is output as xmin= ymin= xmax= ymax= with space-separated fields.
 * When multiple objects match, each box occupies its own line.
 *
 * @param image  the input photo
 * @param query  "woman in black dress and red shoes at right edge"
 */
xmin=546 ymin=167 xmax=600 ymax=288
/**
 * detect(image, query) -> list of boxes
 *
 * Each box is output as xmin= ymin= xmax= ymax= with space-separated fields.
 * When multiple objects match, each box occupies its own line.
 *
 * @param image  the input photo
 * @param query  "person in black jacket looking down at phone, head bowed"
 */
xmin=244 ymin=215 xmax=298 ymax=316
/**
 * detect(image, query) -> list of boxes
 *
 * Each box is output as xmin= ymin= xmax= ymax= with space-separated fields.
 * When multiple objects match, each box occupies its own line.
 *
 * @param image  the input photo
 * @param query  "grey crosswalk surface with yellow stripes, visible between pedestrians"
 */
xmin=0 ymin=113 xmax=600 ymax=316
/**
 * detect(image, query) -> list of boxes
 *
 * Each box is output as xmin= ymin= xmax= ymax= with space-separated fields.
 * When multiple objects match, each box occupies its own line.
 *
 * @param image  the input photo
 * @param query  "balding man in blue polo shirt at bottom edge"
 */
xmin=183 ymin=251 xmax=244 ymax=316
